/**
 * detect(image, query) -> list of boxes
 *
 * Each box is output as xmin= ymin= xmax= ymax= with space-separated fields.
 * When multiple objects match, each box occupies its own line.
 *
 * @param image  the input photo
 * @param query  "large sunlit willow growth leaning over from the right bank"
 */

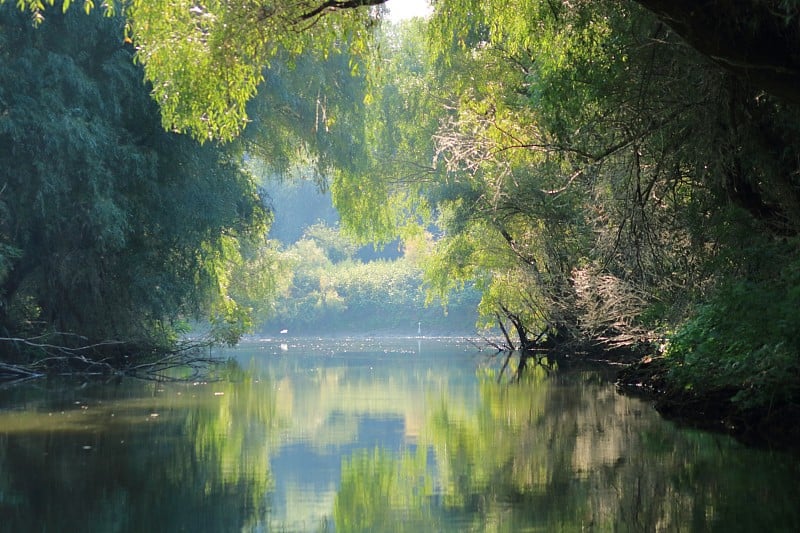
xmin=322 ymin=0 xmax=798 ymax=362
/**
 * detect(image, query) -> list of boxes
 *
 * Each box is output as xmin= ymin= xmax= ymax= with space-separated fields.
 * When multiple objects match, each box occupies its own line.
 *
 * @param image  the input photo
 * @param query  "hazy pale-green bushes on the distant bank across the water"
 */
xmin=258 ymin=223 xmax=480 ymax=336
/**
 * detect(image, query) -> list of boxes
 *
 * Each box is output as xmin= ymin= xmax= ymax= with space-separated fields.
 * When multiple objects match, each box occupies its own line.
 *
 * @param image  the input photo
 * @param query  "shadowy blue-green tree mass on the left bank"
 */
xmin=0 ymin=6 xmax=267 ymax=354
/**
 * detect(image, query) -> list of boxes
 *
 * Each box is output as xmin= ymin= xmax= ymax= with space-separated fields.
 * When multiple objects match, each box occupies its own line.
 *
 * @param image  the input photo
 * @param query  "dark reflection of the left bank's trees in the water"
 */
xmin=0 ymin=370 xmax=275 ymax=532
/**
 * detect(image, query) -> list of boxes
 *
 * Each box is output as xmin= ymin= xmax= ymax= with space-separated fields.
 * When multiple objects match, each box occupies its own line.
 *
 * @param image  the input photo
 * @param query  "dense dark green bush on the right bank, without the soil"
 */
xmin=667 ymin=245 xmax=800 ymax=408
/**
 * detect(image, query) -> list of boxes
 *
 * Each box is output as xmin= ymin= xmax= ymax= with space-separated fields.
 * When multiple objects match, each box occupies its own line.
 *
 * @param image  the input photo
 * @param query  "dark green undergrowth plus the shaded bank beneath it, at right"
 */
xmin=620 ymin=248 xmax=800 ymax=446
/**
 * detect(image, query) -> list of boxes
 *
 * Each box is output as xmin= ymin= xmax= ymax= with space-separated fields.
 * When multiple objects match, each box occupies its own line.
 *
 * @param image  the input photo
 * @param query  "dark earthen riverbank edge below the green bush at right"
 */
xmin=617 ymin=357 xmax=800 ymax=453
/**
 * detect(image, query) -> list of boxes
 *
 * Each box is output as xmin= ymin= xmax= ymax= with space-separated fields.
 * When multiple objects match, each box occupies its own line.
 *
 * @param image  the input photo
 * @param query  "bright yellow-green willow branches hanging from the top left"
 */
xmin=7 ymin=0 xmax=386 ymax=141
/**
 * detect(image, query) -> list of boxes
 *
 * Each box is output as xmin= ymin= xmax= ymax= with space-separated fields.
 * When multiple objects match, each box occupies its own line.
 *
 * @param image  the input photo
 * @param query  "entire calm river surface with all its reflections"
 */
xmin=0 ymin=339 xmax=800 ymax=532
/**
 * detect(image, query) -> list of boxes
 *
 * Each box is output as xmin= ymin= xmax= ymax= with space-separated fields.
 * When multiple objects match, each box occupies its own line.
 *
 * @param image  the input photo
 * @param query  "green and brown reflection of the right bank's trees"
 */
xmin=335 ymin=369 xmax=800 ymax=532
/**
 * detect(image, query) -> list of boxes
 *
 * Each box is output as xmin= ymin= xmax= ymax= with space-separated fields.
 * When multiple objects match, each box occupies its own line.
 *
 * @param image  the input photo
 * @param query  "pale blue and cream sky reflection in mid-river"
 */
xmin=248 ymin=338 xmax=476 ymax=530
